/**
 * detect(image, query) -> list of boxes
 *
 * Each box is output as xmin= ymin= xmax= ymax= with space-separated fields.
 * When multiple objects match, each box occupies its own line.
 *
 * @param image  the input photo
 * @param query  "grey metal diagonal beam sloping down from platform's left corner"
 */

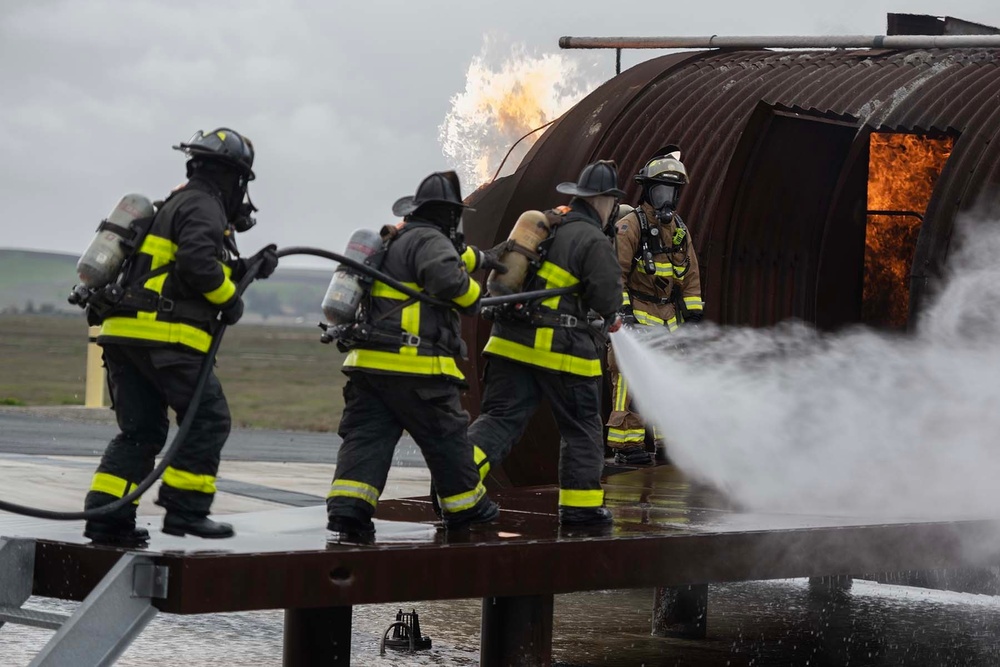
xmin=29 ymin=553 xmax=167 ymax=667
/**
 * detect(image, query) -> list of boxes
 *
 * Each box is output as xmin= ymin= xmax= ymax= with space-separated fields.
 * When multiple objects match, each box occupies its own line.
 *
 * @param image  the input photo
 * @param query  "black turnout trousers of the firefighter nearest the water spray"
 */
xmin=469 ymin=356 xmax=604 ymax=507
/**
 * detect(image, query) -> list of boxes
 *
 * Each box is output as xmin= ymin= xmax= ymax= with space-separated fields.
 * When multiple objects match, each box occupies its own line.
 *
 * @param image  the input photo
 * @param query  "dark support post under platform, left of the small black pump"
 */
xmin=281 ymin=607 xmax=352 ymax=667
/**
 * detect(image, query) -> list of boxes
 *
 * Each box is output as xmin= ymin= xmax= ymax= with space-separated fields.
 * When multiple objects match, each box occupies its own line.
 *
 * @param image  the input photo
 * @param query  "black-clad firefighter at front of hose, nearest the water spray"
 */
xmin=469 ymin=161 xmax=625 ymax=526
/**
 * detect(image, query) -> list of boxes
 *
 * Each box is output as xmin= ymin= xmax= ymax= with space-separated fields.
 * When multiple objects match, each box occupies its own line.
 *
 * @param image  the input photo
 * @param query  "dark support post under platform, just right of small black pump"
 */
xmin=479 ymin=595 xmax=553 ymax=667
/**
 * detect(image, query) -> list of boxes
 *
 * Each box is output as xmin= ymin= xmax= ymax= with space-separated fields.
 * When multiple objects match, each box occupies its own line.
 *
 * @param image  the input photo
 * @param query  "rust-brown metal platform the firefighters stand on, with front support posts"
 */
xmin=0 ymin=466 xmax=1000 ymax=666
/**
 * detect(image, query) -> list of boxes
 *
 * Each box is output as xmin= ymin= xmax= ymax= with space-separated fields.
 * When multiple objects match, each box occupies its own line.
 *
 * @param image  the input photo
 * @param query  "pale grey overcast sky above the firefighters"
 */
xmin=0 ymin=0 xmax=1000 ymax=265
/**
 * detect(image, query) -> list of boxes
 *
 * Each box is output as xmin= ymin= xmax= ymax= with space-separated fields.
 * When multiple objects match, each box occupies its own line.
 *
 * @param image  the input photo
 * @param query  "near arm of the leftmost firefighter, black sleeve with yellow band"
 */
xmin=175 ymin=195 xmax=239 ymax=309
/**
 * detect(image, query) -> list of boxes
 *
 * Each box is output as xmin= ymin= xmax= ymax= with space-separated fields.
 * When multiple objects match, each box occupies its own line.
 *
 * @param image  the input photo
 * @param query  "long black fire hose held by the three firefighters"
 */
xmin=0 ymin=246 xmax=577 ymax=521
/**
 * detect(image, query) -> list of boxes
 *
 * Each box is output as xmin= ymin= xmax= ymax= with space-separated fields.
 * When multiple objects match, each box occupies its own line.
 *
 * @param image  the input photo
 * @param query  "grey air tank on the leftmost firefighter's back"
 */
xmin=76 ymin=194 xmax=153 ymax=289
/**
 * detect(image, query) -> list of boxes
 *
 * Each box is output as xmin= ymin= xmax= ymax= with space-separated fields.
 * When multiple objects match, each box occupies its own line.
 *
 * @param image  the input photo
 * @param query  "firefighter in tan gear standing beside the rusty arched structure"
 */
xmin=608 ymin=146 xmax=704 ymax=465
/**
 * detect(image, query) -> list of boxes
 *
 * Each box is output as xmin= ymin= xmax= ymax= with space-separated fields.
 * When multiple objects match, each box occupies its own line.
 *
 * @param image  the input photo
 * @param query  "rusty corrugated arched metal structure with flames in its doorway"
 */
xmin=465 ymin=44 xmax=1000 ymax=485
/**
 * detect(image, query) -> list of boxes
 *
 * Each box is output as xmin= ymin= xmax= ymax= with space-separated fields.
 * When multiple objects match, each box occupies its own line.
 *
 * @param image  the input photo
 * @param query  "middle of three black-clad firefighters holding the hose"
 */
xmin=327 ymin=171 xmax=503 ymax=542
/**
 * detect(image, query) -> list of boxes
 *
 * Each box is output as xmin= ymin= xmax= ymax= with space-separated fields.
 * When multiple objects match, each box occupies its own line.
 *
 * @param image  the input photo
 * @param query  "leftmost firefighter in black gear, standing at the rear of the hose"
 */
xmin=84 ymin=128 xmax=278 ymax=546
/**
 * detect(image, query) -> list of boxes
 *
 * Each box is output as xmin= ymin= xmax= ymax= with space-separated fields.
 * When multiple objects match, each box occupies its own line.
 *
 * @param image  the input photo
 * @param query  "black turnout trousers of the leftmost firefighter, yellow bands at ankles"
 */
xmin=85 ymin=344 xmax=231 ymax=524
